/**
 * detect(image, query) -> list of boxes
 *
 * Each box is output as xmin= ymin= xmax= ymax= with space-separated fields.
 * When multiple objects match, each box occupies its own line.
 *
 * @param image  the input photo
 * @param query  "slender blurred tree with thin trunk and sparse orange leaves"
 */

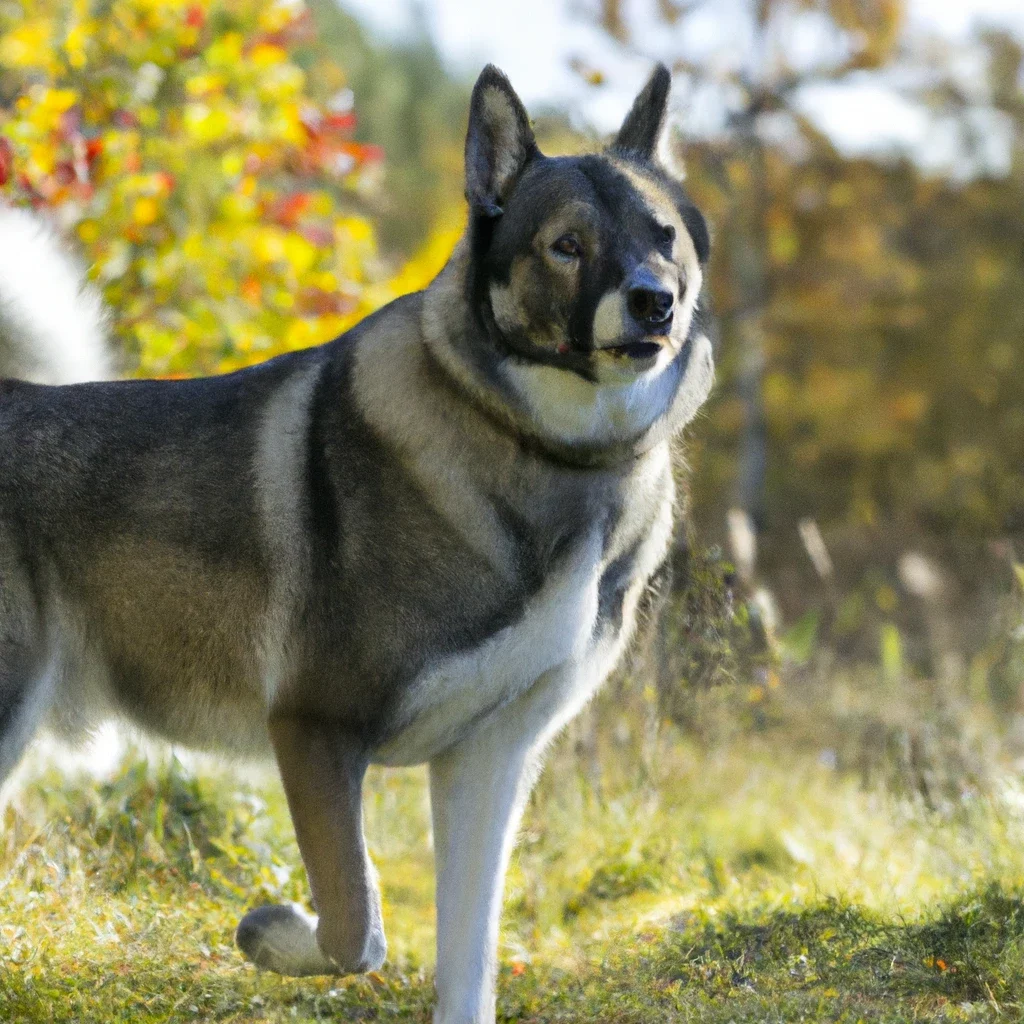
xmin=585 ymin=0 xmax=903 ymax=524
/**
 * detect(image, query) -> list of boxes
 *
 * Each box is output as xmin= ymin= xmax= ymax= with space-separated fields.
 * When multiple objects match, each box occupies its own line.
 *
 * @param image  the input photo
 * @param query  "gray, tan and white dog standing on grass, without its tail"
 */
xmin=0 ymin=67 xmax=713 ymax=1024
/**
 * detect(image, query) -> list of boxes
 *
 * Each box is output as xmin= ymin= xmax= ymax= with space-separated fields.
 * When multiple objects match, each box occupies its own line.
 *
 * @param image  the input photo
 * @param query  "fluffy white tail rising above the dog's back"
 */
xmin=0 ymin=206 xmax=114 ymax=384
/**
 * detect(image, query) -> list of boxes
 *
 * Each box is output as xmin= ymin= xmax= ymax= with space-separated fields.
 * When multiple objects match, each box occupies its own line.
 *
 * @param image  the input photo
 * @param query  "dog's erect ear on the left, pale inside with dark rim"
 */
xmin=466 ymin=65 xmax=539 ymax=217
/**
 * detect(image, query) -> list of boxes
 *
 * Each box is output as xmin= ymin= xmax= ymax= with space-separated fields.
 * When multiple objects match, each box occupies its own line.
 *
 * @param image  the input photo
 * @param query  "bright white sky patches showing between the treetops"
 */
xmin=341 ymin=0 xmax=1024 ymax=170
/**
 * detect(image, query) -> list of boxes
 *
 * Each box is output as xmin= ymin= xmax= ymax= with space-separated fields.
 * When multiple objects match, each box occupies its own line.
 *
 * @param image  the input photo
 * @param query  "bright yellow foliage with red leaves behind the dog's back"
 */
xmin=0 ymin=0 xmax=458 ymax=376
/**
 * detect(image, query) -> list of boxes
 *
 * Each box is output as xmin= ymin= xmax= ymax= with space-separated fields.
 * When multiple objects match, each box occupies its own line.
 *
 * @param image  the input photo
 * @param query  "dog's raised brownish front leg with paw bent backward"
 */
xmin=238 ymin=718 xmax=387 ymax=975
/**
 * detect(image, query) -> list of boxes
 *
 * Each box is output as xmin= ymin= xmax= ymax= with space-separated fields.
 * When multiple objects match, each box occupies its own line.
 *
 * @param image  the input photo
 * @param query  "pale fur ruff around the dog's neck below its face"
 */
xmin=422 ymin=247 xmax=714 ymax=469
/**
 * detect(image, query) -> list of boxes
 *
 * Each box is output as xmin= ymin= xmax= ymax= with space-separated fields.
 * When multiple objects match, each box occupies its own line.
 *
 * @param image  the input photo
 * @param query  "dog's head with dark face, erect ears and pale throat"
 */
xmin=430 ymin=66 xmax=714 ymax=455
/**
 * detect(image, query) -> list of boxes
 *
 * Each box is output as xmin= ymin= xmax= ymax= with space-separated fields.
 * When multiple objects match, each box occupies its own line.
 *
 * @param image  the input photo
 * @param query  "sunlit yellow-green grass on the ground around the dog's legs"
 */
xmin=0 ymin=712 xmax=1024 ymax=1024
